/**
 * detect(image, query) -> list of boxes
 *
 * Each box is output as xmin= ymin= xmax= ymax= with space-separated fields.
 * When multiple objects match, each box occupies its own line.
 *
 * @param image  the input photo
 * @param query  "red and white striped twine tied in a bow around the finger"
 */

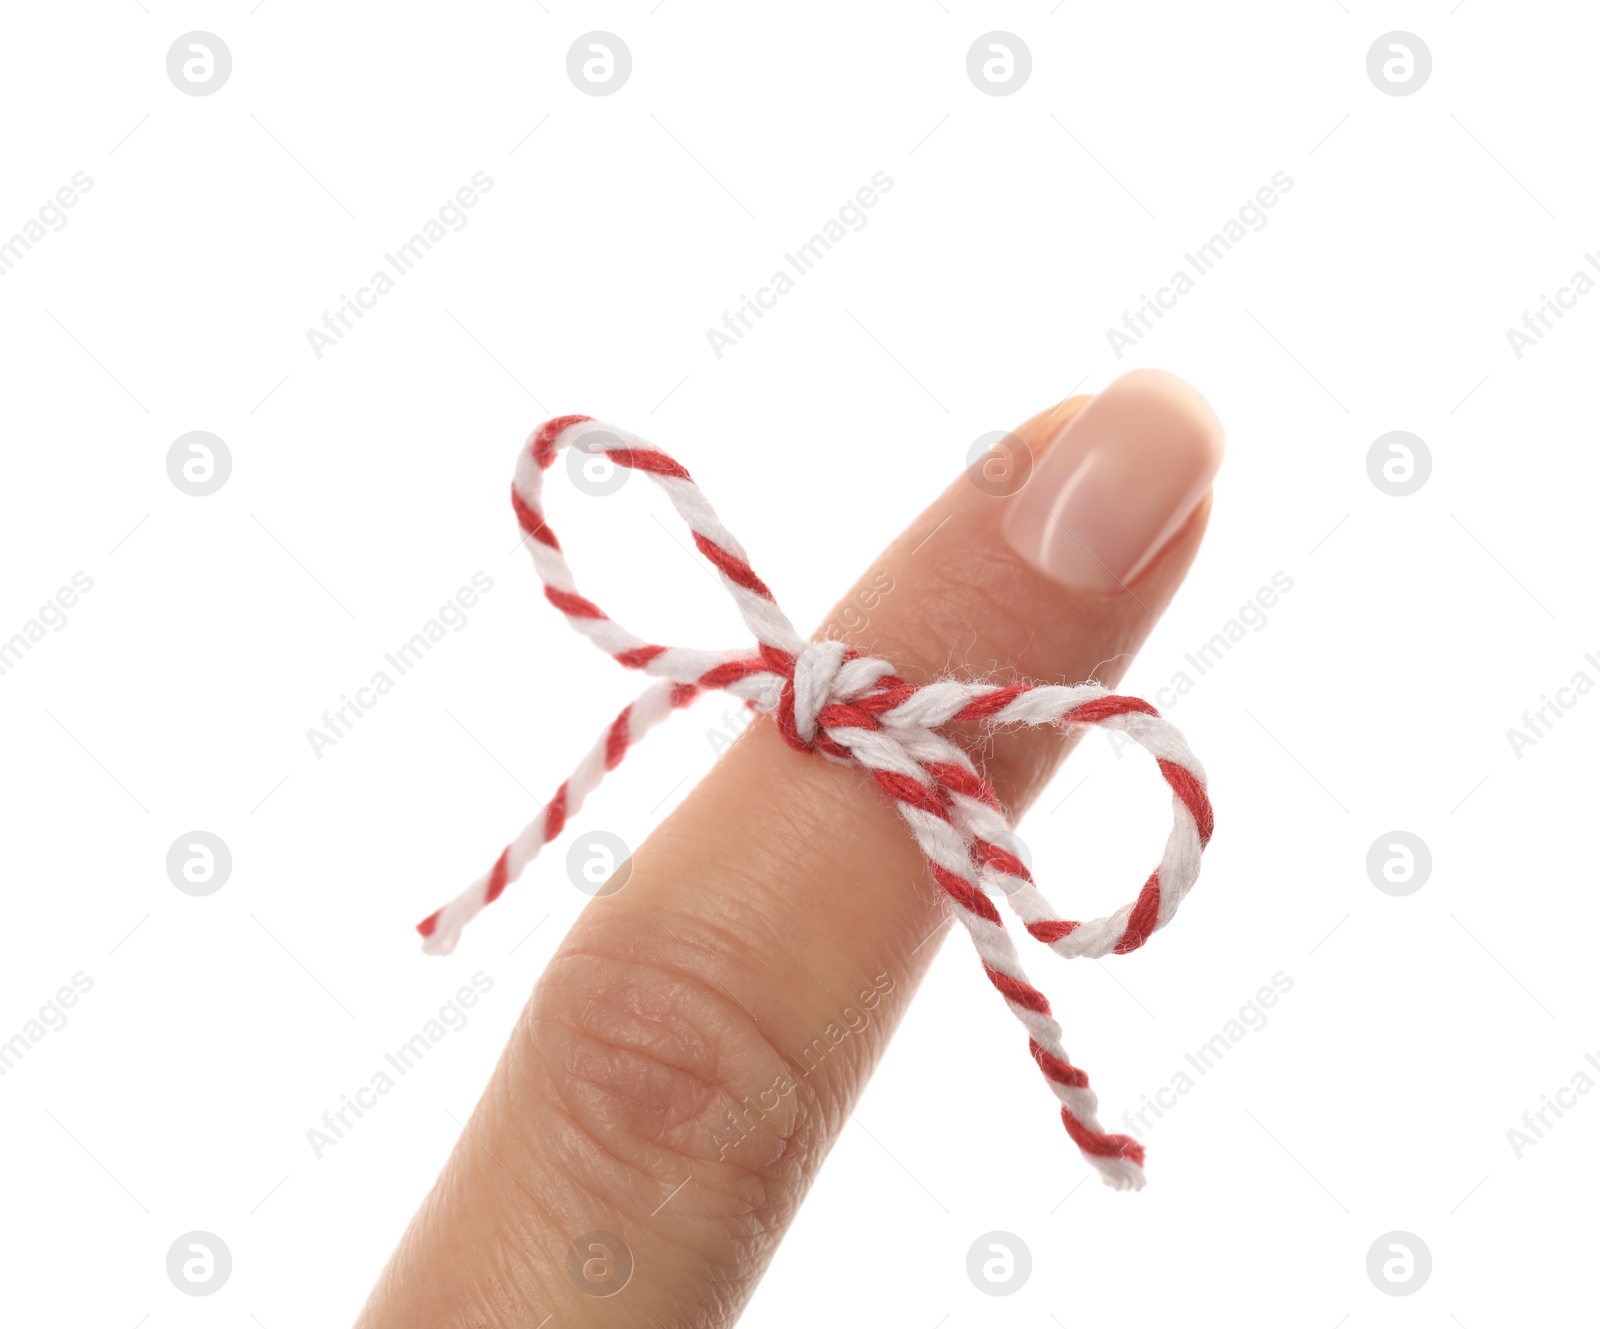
xmin=418 ymin=416 xmax=1211 ymax=1190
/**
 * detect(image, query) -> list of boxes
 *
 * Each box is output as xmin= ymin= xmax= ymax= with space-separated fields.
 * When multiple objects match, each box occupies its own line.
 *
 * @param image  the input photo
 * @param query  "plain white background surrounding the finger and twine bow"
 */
xmin=0 ymin=0 xmax=1600 ymax=1329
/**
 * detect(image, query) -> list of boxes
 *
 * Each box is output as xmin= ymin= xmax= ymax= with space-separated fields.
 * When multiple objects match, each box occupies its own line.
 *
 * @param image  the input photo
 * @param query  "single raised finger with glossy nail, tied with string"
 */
xmin=358 ymin=369 xmax=1222 ymax=1329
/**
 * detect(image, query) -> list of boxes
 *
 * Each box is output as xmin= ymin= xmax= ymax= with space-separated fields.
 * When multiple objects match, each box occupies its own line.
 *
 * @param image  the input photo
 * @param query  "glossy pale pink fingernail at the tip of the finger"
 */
xmin=1003 ymin=369 xmax=1222 ymax=592
